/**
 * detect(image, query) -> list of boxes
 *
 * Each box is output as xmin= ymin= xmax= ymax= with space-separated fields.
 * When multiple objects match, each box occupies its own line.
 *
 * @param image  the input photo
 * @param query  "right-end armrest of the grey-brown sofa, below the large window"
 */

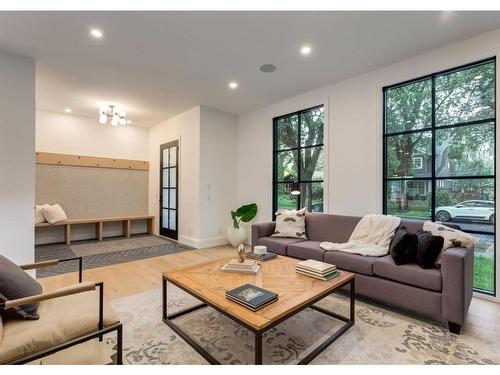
xmin=441 ymin=247 xmax=474 ymax=324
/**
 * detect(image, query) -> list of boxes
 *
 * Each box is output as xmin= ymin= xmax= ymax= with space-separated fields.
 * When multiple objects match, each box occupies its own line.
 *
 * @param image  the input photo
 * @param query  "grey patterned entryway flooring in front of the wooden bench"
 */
xmin=35 ymin=235 xmax=190 ymax=278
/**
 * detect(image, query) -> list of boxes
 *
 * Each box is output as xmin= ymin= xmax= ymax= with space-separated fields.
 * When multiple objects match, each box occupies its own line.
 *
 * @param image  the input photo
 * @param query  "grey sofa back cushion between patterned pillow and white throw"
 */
xmin=306 ymin=212 xmax=361 ymax=243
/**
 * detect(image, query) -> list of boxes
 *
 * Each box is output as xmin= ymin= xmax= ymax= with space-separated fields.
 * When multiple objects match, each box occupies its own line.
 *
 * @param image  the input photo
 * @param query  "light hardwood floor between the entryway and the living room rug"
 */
xmin=38 ymin=246 xmax=500 ymax=342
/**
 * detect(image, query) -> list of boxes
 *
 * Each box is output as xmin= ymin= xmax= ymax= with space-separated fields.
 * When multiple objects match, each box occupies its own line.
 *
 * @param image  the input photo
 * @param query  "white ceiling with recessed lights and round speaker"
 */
xmin=0 ymin=11 xmax=500 ymax=127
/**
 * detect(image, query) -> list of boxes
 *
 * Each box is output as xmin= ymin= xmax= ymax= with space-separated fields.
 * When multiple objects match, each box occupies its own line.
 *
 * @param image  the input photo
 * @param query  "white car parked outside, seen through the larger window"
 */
xmin=436 ymin=200 xmax=495 ymax=224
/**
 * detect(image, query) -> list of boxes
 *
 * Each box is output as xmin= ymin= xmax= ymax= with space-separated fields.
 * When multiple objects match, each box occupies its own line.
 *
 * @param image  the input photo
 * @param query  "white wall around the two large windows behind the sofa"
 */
xmin=238 ymin=29 xmax=500 ymax=300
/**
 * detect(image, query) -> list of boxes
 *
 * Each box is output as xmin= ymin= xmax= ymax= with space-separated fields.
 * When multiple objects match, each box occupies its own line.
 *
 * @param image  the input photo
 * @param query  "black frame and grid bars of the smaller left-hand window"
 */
xmin=272 ymin=104 xmax=325 ymax=220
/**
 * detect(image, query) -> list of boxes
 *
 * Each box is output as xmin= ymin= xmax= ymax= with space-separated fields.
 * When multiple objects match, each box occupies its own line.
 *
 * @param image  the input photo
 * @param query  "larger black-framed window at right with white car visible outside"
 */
xmin=383 ymin=58 xmax=496 ymax=295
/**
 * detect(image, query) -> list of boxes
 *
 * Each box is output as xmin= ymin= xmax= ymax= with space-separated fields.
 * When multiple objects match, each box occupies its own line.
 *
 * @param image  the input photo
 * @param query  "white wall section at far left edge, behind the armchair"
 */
xmin=0 ymin=50 xmax=35 ymax=264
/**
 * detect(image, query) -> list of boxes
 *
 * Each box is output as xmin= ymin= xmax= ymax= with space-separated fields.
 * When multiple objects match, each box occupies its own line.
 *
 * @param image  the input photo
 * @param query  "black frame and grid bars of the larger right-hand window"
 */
xmin=382 ymin=56 xmax=497 ymax=297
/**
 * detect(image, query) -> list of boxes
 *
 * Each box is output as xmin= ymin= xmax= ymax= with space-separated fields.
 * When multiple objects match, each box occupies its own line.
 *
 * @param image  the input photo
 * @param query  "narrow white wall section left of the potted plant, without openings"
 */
xmin=200 ymin=106 xmax=238 ymax=247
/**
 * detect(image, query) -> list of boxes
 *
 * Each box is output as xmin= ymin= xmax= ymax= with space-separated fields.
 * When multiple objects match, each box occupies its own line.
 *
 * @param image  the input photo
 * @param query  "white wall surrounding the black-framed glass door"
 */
xmin=149 ymin=106 xmax=200 ymax=247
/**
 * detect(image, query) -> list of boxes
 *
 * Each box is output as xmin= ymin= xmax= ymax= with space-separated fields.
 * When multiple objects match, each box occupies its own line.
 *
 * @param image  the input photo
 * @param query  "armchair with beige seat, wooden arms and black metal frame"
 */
xmin=0 ymin=257 xmax=123 ymax=364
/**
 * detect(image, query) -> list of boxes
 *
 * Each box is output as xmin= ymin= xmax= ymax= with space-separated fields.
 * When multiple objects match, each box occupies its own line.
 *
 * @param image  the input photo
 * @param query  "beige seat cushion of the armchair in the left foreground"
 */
xmin=0 ymin=291 xmax=120 ymax=363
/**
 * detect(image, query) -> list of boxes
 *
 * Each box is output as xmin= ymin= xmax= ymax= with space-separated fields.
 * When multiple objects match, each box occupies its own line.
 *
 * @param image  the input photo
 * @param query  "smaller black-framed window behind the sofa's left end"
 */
xmin=273 ymin=105 xmax=324 ymax=215
